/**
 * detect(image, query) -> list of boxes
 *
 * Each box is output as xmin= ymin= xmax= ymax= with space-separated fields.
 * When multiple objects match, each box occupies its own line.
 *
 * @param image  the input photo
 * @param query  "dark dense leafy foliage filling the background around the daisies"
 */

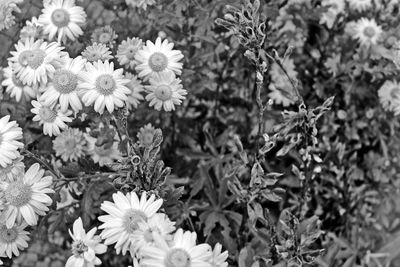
xmin=0 ymin=0 xmax=400 ymax=267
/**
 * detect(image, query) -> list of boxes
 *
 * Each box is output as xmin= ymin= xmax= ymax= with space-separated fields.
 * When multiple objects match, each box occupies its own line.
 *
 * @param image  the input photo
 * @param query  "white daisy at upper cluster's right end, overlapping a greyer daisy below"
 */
xmin=135 ymin=37 xmax=183 ymax=77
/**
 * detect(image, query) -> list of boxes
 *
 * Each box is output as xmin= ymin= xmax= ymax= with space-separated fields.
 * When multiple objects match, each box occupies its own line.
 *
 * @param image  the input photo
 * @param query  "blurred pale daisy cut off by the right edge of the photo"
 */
xmin=378 ymin=81 xmax=400 ymax=115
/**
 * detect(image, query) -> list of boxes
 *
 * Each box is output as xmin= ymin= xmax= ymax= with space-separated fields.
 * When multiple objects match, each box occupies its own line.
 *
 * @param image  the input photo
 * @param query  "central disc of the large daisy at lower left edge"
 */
xmin=4 ymin=181 xmax=32 ymax=207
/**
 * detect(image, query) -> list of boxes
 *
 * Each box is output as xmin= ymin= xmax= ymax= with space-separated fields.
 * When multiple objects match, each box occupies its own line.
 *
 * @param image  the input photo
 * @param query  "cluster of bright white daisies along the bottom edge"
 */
xmin=66 ymin=192 xmax=228 ymax=267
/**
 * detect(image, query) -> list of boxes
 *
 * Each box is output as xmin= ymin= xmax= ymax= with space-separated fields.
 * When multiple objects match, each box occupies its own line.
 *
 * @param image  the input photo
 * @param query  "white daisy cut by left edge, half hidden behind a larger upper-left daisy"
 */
xmin=1 ymin=63 xmax=38 ymax=102
